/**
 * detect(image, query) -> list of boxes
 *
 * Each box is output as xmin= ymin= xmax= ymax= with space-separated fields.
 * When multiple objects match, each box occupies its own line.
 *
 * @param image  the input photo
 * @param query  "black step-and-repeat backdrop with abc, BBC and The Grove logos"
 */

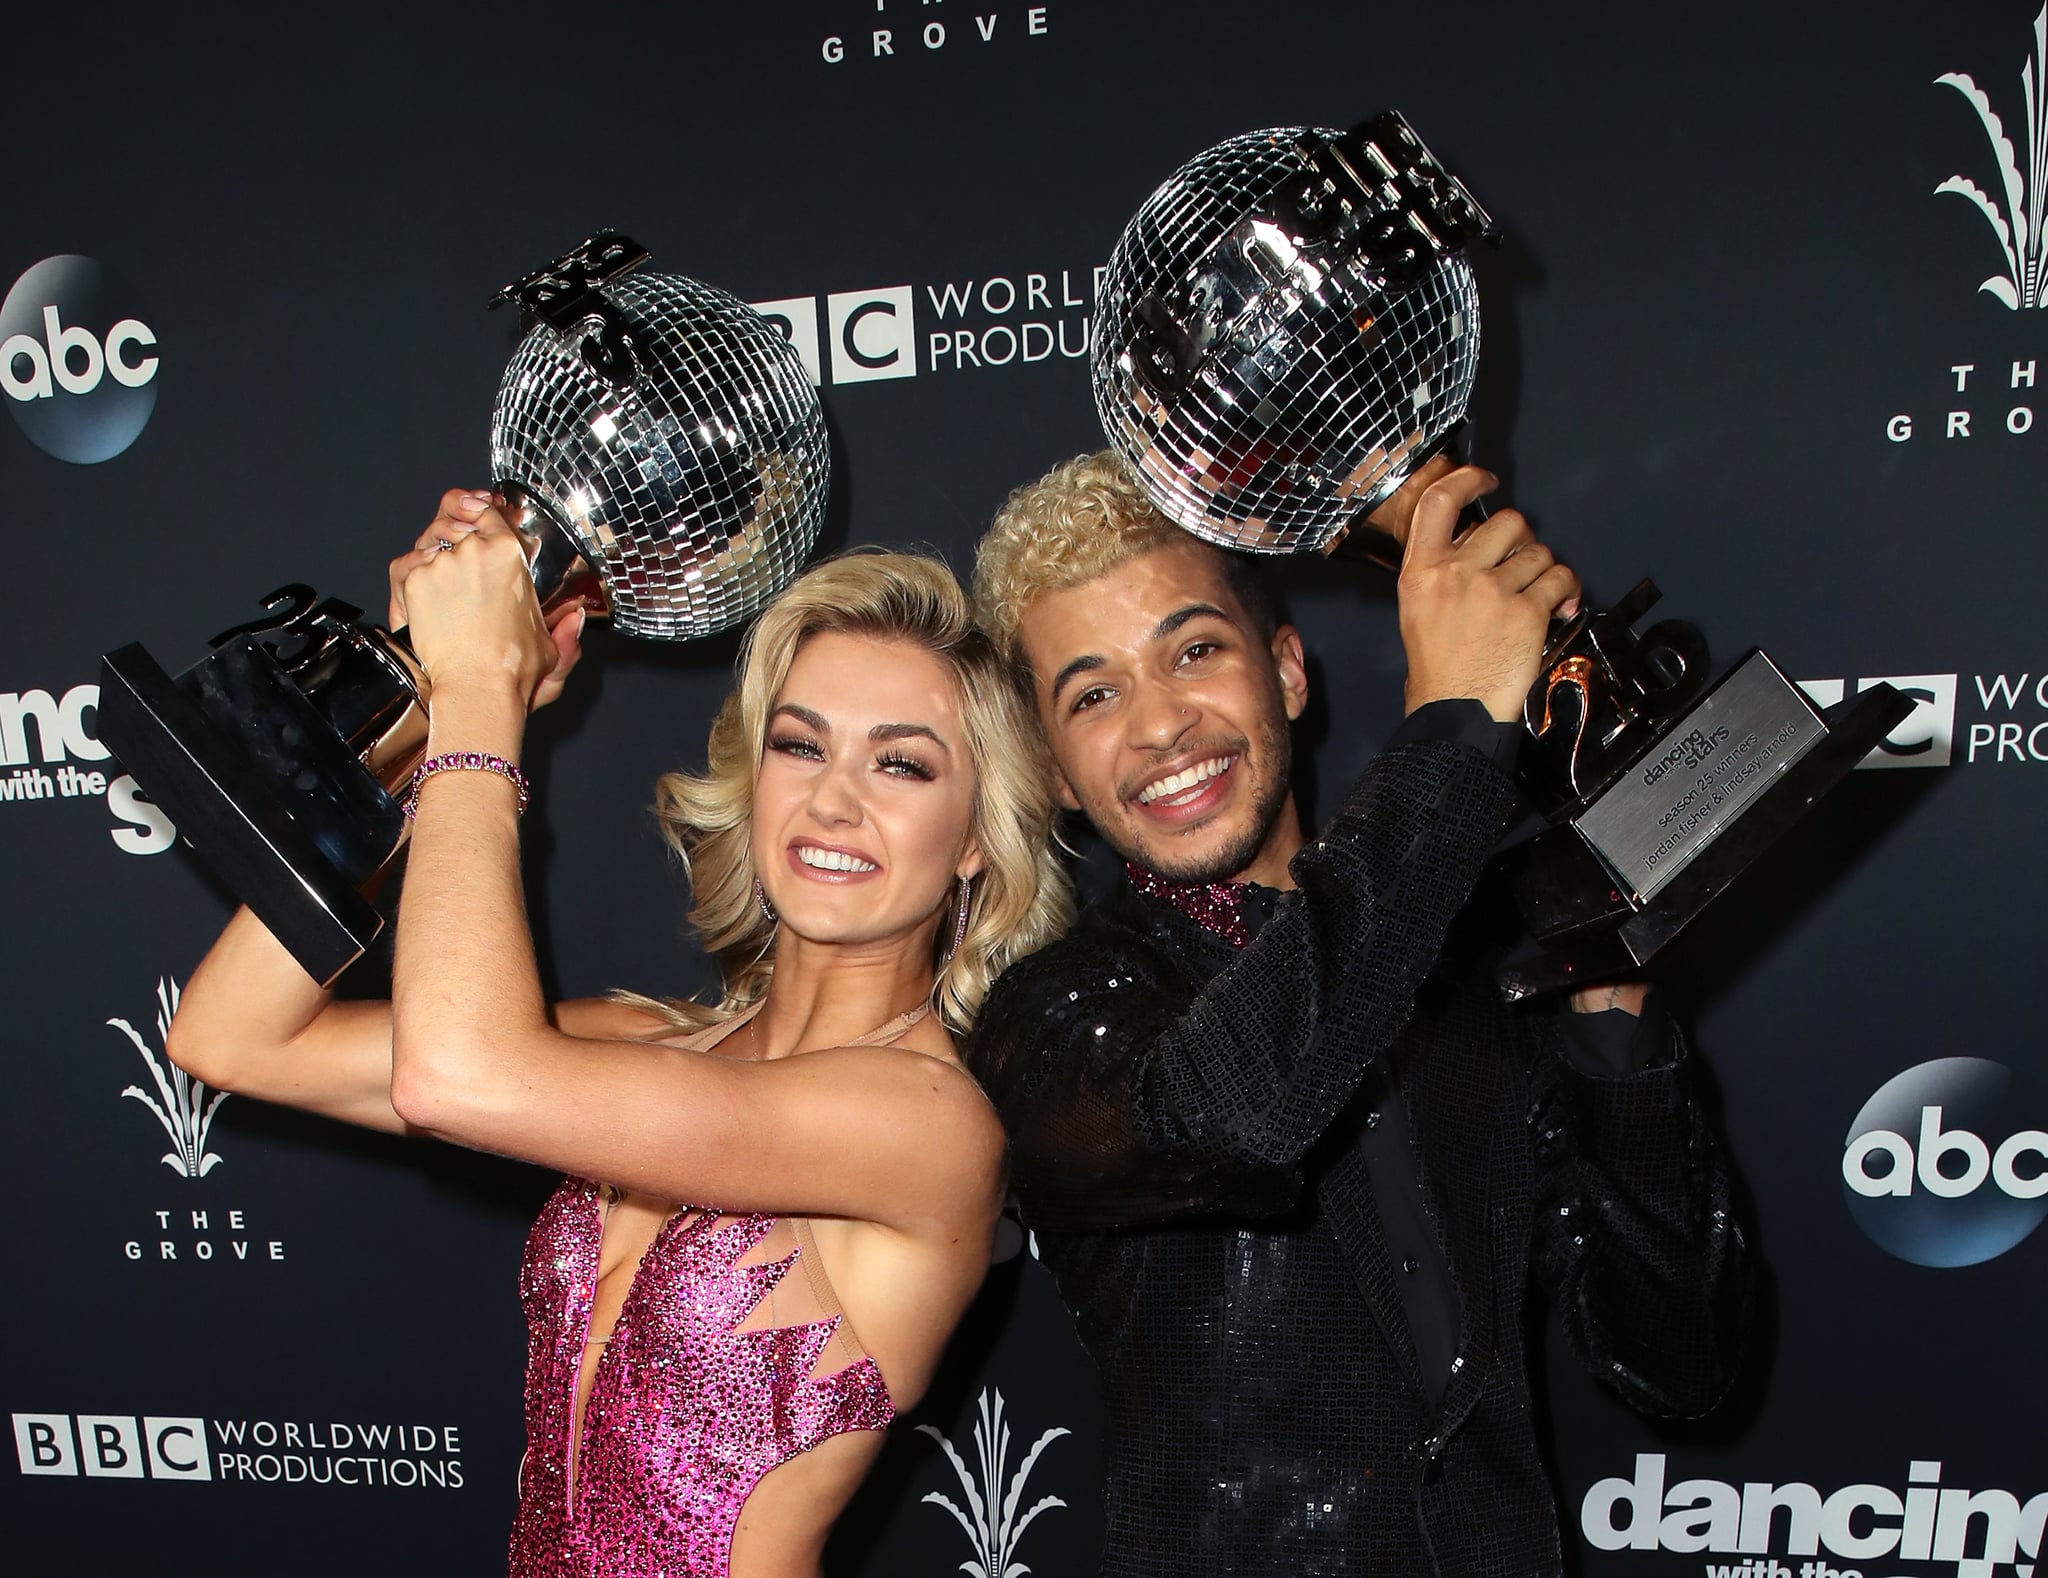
xmin=0 ymin=0 xmax=2048 ymax=1578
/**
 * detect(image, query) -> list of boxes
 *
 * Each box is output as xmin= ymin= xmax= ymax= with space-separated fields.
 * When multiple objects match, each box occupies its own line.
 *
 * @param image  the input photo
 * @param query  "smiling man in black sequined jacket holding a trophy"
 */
xmin=969 ymin=452 xmax=1749 ymax=1578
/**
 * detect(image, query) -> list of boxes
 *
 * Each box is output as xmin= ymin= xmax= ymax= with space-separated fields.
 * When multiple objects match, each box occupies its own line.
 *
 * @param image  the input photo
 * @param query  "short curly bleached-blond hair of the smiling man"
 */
xmin=975 ymin=450 xmax=1280 ymax=677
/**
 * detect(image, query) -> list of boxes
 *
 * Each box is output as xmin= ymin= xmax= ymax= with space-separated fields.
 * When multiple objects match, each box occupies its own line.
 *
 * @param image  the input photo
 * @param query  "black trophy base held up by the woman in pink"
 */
xmin=98 ymin=637 xmax=406 ymax=984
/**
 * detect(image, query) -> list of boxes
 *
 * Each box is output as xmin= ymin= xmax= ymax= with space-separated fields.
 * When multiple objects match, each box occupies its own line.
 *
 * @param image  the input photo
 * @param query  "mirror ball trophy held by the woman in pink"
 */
xmin=100 ymin=231 xmax=829 ymax=982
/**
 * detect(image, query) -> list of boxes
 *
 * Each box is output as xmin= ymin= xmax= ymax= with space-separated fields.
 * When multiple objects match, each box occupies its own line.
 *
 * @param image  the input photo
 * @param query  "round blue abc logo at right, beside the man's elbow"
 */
xmin=1841 ymin=1058 xmax=2048 ymax=1265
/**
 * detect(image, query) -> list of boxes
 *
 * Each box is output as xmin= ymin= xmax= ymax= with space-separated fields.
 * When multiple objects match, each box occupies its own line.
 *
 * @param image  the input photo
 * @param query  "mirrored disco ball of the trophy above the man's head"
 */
xmin=1092 ymin=117 xmax=1491 ymax=553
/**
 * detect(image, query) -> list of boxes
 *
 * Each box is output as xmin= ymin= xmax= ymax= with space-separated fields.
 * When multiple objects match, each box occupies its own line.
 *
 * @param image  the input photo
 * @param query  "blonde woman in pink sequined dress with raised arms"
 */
xmin=170 ymin=493 xmax=1071 ymax=1578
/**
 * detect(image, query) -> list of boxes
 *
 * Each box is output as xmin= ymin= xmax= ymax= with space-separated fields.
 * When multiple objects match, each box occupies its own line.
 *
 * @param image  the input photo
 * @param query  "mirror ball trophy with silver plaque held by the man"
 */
xmin=1090 ymin=113 xmax=1911 ymax=999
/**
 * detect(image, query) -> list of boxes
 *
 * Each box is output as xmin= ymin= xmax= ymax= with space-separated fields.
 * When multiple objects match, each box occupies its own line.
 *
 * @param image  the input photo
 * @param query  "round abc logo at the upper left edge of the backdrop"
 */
xmin=0 ymin=254 xmax=158 ymax=465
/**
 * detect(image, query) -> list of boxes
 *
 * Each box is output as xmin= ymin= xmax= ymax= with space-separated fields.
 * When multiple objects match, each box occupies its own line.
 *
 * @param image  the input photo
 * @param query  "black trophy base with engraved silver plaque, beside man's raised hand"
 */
xmin=1495 ymin=667 xmax=1913 ymax=1001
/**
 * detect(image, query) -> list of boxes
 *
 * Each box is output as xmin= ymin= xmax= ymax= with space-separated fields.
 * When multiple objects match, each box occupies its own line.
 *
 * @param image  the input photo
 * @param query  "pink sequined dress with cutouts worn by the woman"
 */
xmin=510 ymin=1015 xmax=913 ymax=1578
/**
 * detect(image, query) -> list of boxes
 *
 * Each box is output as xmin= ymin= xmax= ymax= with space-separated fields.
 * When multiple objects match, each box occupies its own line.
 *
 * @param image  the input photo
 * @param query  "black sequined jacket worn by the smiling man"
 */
xmin=969 ymin=739 xmax=1747 ymax=1578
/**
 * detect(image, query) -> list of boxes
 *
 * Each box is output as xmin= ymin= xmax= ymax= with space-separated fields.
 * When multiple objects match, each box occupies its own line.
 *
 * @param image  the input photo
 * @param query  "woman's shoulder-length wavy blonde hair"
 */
xmin=614 ymin=553 xmax=1073 ymax=1034
